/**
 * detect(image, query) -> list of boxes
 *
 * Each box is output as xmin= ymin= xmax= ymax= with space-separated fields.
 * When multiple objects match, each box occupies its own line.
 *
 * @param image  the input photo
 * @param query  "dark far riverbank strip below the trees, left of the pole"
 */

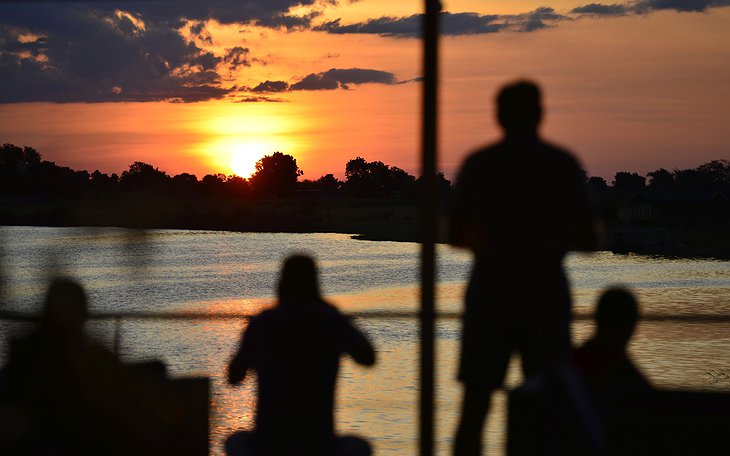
xmin=0 ymin=196 xmax=419 ymax=242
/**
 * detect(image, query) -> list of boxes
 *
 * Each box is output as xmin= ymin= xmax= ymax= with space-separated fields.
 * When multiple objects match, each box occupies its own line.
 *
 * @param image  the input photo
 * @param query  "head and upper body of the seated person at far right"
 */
xmin=573 ymin=288 xmax=653 ymax=410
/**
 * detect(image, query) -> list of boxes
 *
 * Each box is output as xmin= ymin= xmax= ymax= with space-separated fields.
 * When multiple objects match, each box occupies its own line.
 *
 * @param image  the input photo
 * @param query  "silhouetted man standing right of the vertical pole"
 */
xmin=451 ymin=81 xmax=597 ymax=456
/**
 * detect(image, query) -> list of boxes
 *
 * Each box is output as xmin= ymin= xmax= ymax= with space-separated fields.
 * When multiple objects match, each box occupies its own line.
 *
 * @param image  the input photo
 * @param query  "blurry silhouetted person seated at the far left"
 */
xmin=0 ymin=279 xmax=175 ymax=455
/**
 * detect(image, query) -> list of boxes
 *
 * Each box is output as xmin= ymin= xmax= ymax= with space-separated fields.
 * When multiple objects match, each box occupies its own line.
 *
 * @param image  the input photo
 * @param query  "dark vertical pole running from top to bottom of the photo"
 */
xmin=419 ymin=0 xmax=441 ymax=456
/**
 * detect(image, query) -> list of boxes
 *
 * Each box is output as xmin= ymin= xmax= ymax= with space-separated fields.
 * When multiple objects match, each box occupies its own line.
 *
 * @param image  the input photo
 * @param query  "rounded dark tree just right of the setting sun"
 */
xmin=250 ymin=152 xmax=304 ymax=196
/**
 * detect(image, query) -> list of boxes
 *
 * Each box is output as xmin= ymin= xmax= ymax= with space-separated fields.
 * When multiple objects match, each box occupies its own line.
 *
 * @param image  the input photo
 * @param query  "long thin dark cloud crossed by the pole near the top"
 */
xmin=314 ymin=7 xmax=568 ymax=38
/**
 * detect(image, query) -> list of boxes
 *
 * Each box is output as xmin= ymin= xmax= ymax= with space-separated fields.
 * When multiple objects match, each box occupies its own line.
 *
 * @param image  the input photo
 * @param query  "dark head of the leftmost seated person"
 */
xmin=43 ymin=278 xmax=89 ymax=334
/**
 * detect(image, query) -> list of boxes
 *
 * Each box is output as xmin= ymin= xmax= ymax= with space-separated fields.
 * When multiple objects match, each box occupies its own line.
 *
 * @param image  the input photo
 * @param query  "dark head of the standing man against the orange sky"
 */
xmin=497 ymin=81 xmax=542 ymax=134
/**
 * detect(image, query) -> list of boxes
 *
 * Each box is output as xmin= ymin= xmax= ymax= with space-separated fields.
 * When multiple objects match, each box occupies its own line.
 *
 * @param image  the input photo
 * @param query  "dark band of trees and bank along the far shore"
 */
xmin=0 ymin=144 xmax=730 ymax=259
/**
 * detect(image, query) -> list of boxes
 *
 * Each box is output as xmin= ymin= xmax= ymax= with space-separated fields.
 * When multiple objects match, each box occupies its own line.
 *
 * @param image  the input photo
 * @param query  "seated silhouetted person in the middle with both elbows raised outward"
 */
xmin=226 ymin=256 xmax=375 ymax=456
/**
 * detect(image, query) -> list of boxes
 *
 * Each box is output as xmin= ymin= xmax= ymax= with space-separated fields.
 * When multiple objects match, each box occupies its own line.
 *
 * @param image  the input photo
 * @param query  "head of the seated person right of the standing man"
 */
xmin=595 ymin=288 xmax=639 ymax=345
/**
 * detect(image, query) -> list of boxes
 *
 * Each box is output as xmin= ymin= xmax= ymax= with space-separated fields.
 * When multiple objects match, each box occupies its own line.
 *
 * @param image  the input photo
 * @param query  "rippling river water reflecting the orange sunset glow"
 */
xmin=0 ymin=227 xmax=730 ymax=455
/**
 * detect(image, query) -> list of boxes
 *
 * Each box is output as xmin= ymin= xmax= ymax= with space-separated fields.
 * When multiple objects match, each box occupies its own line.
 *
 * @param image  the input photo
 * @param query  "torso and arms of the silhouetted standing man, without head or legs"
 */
xmin=452 ymin=135 xmax=590 ymax=264
